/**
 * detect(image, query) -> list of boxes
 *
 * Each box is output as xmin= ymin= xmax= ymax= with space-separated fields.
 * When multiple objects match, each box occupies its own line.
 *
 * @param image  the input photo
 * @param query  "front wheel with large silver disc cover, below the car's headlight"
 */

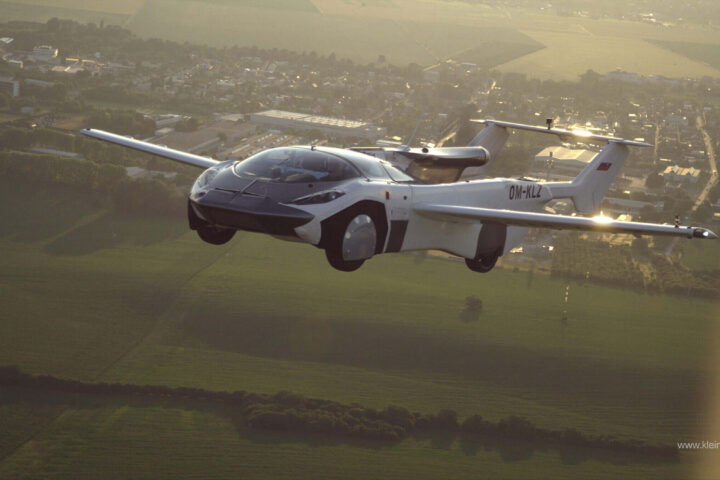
xmin=325 ymin=209 xmax=378 ymax=272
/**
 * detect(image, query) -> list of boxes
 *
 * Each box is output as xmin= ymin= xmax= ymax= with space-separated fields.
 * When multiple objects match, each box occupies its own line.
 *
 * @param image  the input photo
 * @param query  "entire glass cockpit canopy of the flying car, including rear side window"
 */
xmin=233 ymin=147 xmax=414 ymax=183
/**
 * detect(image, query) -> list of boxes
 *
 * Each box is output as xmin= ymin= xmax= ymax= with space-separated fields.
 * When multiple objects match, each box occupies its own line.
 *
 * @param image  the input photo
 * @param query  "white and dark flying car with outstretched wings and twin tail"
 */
xmin=81 ymin=120 xmax=717 ymax=272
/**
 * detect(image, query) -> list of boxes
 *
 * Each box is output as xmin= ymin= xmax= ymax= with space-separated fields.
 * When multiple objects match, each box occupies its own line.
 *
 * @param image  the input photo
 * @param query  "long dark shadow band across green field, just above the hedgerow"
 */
xmin=178 ymin=311 xmax=704 ymax=410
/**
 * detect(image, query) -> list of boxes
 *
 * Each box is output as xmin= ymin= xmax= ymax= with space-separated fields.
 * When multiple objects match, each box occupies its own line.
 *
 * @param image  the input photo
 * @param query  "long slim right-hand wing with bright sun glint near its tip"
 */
xmin=413 ymin=203 xmax=717 ymax=239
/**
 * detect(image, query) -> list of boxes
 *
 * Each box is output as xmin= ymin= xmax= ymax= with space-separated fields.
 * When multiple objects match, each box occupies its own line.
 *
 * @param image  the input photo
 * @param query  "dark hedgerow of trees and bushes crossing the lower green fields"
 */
xmin=0 ymin=365 xmax=678 ymax=462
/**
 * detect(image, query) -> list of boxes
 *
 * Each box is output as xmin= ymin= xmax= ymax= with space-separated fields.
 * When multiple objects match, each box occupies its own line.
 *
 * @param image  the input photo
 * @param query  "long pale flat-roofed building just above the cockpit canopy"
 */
xmin=250 ymin=110 xmax=386 ymax=142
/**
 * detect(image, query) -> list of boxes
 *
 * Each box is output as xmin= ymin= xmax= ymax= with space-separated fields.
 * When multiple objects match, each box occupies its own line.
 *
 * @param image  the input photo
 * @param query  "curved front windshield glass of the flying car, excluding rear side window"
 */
xmin=234 ymin=147 xmax=360 ymax=183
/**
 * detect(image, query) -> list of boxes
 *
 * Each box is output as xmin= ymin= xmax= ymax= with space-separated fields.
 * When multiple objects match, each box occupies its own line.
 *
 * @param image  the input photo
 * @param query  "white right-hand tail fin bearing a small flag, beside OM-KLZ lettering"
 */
xmin=547 ymin=142 xmax=630 ymax=213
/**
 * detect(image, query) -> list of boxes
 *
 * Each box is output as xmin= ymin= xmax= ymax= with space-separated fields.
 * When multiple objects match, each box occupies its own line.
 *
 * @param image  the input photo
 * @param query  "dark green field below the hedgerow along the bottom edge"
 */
xmin=0 ymin=392 xmax=687 ymax=479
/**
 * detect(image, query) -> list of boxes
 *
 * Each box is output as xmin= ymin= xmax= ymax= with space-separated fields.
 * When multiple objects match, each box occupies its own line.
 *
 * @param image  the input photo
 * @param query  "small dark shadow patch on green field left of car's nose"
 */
xmin=45 ymin=212 xmax=187 ymax=255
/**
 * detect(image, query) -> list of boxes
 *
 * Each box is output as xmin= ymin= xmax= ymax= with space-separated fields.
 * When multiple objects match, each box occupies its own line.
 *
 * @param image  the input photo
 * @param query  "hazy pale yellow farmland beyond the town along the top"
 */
xmin=2 ymin=0 xmax=720 ymax=80
